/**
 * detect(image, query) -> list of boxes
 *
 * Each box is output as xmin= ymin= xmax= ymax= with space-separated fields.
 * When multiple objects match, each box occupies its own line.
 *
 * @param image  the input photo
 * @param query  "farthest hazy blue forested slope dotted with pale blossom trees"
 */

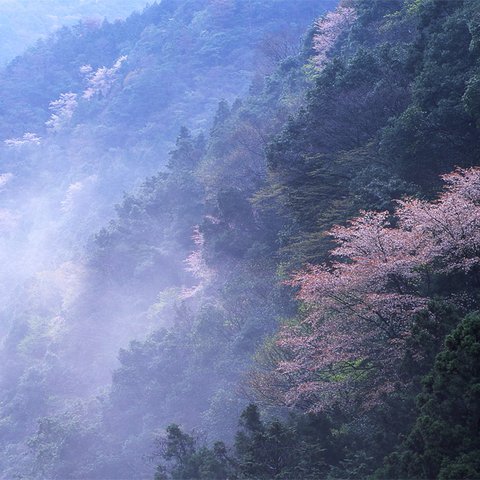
xmin=0 ymin=0 xmax=332 ymax=296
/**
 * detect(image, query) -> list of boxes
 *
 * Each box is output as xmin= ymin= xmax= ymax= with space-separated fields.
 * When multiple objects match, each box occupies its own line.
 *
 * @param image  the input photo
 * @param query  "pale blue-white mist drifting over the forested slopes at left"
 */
xmin=0 ymin=0 xmax=335 ymax=478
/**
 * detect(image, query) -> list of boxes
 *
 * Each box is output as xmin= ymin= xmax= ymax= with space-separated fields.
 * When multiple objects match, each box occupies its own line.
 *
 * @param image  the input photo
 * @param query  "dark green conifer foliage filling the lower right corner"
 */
xmin=379 ymin=313 xmax=480 ymax=479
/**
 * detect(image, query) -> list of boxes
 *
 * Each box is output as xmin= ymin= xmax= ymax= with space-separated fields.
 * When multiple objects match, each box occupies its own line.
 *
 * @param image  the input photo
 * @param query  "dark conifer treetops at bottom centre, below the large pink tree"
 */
xmin=156 ymin=404 xmax=338 ymax=480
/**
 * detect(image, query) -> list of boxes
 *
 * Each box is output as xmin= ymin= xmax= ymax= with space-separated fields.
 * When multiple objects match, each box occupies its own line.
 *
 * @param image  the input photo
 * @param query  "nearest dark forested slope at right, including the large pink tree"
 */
xmin=145 ymin=1 xmax=480 ymax=479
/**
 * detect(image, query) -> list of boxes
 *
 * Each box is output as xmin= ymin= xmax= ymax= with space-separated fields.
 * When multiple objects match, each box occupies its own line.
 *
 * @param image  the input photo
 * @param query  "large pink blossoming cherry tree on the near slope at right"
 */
xmin=276 ymin=168 xmax=480 ymax=411
